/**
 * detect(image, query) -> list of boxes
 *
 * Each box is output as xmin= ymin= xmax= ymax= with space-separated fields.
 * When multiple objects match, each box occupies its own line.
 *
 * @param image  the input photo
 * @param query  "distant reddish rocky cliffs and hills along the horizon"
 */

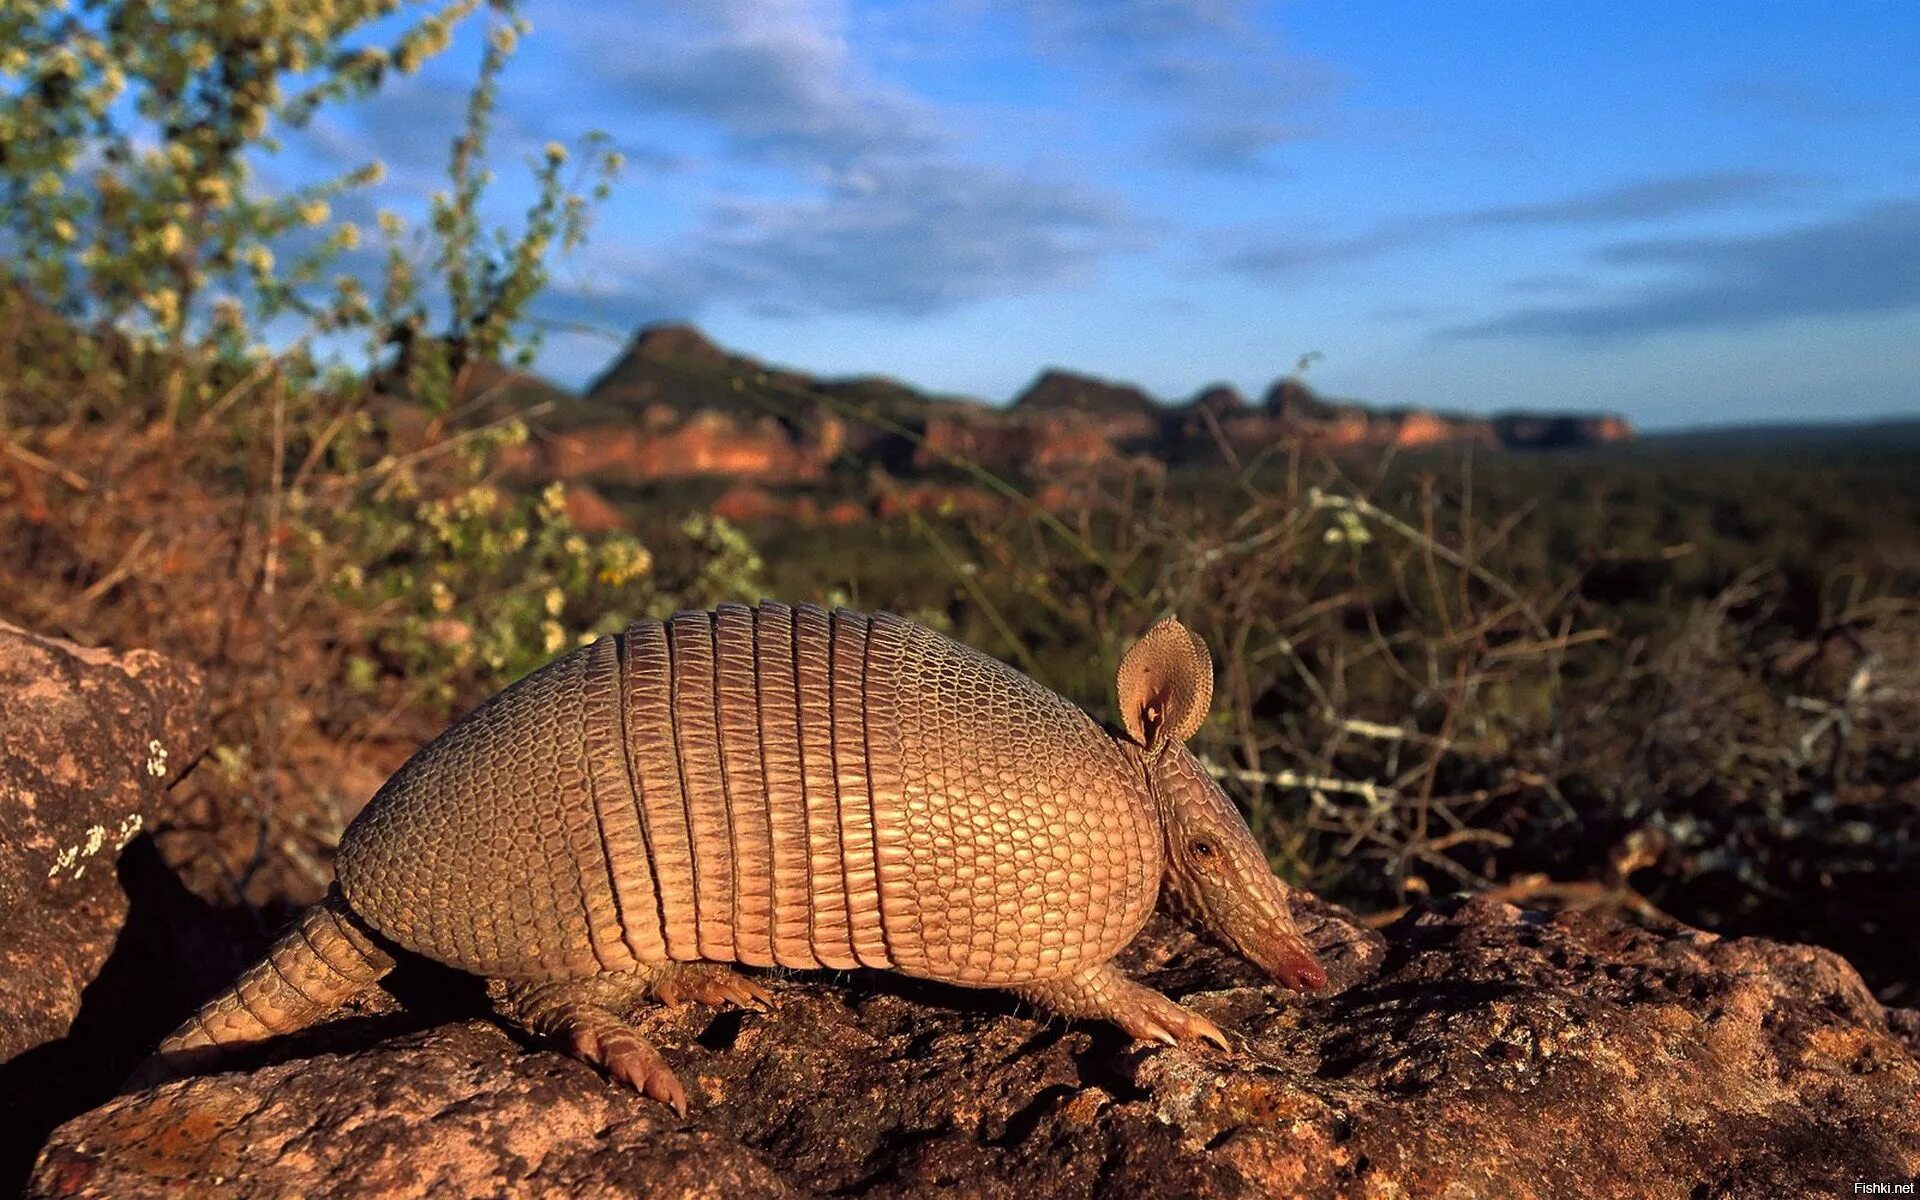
xmin=495 ymin=324 xmax=1632 ymax=509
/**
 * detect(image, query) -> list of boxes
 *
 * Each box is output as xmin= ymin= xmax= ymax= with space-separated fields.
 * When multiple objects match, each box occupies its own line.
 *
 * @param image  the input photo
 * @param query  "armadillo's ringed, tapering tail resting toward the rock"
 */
xmin=127 ymin=887 xmax=394 ymax=1087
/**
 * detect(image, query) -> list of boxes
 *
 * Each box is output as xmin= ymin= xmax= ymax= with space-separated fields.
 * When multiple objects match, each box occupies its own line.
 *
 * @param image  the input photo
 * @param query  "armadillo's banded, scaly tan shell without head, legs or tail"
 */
xmin=338 ymin=603 xmax=1162 ymax=985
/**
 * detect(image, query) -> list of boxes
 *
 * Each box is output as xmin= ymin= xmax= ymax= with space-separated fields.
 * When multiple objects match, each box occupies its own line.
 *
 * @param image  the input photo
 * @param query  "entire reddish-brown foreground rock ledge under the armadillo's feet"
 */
xmin=31 ymin=900 xmax=1920 ymax=1198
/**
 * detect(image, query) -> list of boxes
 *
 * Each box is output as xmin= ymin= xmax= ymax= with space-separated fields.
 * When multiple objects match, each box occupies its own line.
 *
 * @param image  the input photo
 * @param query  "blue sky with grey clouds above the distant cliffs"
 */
xmin=284 ymin=0 xmax=1920 ymax=428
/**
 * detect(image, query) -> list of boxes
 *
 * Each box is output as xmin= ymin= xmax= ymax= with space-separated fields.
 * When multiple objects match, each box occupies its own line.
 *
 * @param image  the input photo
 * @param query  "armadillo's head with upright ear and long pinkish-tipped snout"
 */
xmin=1117 ymin=616 xmax=1327 ymax=991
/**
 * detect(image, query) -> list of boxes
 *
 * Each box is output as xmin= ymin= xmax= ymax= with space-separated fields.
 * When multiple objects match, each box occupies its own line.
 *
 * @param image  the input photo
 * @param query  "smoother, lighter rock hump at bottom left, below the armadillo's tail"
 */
xmin=35 ymin=1021 xmax=793 ymax=1198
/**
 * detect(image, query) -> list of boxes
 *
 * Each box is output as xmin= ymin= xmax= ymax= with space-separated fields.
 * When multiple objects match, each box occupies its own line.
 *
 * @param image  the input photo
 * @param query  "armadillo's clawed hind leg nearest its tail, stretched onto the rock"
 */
xmin=488 ymin=975 xmax=687 ymax=1116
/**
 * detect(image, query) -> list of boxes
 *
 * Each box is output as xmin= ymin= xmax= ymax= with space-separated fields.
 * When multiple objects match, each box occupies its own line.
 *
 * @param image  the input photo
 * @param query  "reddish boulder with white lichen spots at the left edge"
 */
xmin=0 ymin=622 xmax=207 ymax=1192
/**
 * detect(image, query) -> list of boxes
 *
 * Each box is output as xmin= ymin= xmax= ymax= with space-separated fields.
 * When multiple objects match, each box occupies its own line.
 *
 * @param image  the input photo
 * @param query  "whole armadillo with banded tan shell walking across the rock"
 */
xmin=154 ymin=601 xmax=1327 ymax=1112
